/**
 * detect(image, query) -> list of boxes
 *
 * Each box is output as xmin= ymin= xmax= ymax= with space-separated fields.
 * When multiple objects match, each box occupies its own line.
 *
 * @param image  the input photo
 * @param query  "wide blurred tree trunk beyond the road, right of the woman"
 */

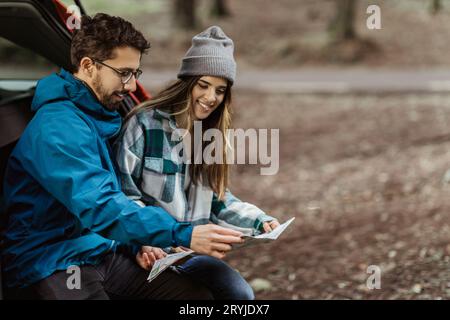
xmin=329 ymin=0 xmax=356 ymax=42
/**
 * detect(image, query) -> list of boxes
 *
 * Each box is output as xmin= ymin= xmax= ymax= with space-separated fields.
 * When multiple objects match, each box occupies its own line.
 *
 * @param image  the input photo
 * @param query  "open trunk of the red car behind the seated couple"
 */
xmin=0 ymin=0 xmax=150 ymax=299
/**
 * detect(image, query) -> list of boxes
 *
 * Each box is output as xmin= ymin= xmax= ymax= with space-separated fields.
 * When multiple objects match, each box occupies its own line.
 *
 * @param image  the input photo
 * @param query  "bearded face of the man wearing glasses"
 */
xmin=92 ymin=47 xmax=141 ymax=111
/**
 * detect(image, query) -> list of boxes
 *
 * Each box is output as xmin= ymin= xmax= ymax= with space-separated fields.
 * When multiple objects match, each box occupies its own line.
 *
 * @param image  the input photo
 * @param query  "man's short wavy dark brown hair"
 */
xmin=70 ymin=13 xmax=150 ymax=72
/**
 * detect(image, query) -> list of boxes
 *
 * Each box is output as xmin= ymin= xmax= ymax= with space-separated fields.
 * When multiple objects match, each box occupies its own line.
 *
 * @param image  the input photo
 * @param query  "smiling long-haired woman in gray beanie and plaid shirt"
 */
xmin=115 ymin=26 xmax=279 ymax=299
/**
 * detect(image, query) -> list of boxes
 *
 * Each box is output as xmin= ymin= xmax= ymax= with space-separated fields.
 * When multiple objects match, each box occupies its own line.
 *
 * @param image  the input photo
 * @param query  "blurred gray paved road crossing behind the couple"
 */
xmin=141 ymin=69 xmax=450 ymax=93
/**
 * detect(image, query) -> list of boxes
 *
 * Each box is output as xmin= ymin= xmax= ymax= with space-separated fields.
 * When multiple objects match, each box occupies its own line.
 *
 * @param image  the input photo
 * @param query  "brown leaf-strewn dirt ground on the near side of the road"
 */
xmin=226 ymin=92 xmax=450 ymax=299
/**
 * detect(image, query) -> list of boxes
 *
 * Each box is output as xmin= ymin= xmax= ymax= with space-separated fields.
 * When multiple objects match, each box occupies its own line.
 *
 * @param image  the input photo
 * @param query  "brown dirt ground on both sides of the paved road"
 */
xmin=37 ymin=0 xmax=450 ymax=299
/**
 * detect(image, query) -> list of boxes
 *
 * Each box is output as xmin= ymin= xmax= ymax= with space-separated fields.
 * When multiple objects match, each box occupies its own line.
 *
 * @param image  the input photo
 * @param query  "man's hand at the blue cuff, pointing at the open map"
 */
xmin=191 ymin=224 xmax=244 ymax=259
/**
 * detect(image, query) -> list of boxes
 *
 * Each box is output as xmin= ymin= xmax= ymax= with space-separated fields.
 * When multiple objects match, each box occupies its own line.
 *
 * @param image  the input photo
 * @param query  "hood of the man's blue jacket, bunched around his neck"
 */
xmin=31 ymin=69 xmax=122 ymax=138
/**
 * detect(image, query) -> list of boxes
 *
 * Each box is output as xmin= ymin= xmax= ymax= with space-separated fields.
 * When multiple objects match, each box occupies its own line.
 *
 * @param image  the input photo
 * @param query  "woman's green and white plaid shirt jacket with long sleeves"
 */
xmin=114 ymin=109 xmax=274 ymax=234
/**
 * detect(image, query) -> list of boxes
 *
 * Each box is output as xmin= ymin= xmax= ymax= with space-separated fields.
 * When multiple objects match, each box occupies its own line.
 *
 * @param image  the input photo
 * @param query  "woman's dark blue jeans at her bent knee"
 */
xmin=176 ymin=255 xmax=255 ymax=300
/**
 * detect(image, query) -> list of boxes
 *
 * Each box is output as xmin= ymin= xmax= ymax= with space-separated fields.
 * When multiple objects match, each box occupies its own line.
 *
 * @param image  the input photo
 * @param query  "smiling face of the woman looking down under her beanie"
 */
xmin=192 ymin=76 xmax=227 ymax=120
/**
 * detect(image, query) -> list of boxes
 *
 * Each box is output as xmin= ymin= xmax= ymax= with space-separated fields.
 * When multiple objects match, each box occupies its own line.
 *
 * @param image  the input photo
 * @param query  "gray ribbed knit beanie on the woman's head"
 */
xmin=178 ymin=26 xmax=236 ymax=84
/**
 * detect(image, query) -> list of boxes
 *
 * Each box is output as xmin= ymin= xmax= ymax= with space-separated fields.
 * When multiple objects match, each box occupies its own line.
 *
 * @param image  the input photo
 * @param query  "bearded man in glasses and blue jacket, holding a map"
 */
xmin=2 ymin=14 xmax=242 ymax=299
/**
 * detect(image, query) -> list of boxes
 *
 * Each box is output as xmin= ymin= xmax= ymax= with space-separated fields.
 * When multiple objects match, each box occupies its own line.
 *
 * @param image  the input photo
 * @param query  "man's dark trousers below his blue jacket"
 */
xmin=5 ymin=253 xmax=213 ymax=300
